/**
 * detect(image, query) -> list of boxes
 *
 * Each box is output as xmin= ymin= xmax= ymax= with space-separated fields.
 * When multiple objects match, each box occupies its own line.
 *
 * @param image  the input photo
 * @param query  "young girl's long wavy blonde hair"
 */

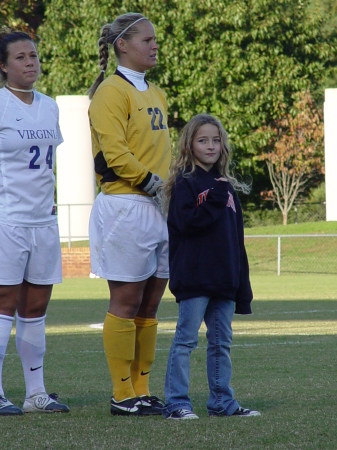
xmin=159 ymin=114 xmax=251 ymax=213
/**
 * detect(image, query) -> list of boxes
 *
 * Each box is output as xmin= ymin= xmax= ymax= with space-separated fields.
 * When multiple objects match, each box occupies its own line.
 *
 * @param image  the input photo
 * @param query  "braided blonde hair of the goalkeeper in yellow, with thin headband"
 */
xmin=89 ymin=13 xmax=148 ymax=99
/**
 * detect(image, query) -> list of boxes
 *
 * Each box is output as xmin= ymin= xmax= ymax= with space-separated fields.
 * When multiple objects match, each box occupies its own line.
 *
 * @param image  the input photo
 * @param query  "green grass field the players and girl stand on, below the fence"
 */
xmin=0 ymin=275 xmax=337 ymax=450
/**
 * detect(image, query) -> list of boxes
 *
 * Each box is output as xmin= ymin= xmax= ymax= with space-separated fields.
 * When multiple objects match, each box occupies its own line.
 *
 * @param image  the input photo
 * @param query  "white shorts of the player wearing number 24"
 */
xmin=0 ymin=223 xmax=62 ymax=285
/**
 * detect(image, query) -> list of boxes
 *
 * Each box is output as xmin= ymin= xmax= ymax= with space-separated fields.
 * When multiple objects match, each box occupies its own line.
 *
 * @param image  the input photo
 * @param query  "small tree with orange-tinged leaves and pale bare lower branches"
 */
xmin=261 ymin=91 xmax=324 ymax=225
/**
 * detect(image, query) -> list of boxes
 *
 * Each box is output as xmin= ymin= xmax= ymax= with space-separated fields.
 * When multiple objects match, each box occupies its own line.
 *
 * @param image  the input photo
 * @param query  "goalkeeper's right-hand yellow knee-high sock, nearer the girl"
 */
xmin=131 ymin=317 xmax=158 ymax=396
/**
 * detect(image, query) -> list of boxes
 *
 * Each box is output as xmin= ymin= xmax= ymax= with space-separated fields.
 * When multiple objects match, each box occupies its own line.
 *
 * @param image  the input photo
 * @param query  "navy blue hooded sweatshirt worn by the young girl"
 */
xmin=167 ymin=166 xmax=253 ymax=314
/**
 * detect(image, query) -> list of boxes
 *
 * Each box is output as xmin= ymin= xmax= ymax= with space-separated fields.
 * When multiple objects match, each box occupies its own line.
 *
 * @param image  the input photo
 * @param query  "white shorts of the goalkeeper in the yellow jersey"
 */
xmin=89 ymin=193 xmax=169 ymax=282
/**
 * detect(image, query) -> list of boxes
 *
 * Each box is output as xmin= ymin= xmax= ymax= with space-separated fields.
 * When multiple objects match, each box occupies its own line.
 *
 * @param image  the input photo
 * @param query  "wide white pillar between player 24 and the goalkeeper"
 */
xmin=56 ymin=95 xmax=96 ymax=242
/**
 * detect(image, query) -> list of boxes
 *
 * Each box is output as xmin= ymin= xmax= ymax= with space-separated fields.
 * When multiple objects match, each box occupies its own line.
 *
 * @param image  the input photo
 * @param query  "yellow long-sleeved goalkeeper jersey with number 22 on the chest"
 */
xmin=89 ymin=73 xmax=171 ymax=195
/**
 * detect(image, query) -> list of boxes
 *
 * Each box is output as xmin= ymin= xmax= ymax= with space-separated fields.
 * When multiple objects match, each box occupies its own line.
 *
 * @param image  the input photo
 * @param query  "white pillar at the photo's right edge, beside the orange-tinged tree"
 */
xmin=324 ymin=89 xmax=337 ymax=221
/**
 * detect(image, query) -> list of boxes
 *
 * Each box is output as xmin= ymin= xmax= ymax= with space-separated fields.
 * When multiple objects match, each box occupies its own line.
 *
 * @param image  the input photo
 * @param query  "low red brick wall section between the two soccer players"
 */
xmin=62 ymin=247 xmax=91 ymax=278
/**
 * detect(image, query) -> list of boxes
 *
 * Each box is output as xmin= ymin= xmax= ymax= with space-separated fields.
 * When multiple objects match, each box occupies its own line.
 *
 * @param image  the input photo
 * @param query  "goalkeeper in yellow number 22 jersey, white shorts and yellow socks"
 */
xmin=89 ymin=13 xmax=171 ymax=415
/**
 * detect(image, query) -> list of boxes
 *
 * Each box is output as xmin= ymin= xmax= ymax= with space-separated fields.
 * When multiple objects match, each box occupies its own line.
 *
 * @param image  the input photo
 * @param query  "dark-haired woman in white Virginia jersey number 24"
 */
xmin=0 ymin=29 xmax=69 ymax=416
